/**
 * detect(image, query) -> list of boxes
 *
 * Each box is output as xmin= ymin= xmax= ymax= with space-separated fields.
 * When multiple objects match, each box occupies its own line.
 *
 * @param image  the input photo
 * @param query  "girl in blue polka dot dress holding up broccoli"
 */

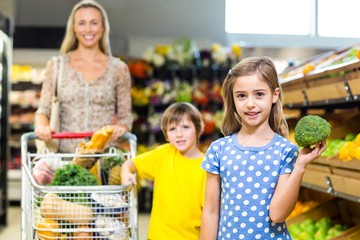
xmin=200 ymin=57 xmax=326 ymax=240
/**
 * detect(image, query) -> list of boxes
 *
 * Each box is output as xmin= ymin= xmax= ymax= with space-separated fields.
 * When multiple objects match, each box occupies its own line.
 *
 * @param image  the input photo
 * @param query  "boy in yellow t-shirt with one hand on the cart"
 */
xmin=121 ymin=102 xmax=206 ymax=240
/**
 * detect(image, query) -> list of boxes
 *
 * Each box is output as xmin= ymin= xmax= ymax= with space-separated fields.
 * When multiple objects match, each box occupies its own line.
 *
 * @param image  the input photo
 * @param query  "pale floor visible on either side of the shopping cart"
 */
xmin=0 ymin=206 xmax=149 ymax=240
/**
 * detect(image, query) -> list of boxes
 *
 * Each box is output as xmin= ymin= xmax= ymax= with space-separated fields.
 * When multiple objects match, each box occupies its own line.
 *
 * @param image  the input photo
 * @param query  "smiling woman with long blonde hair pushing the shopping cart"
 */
xmin=35 ymin=0 xmax=133 ymax=152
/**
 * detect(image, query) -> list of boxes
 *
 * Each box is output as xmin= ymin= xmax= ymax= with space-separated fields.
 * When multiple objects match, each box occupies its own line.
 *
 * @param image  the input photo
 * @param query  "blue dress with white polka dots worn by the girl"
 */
xmin=201 ymin=134 xmax=298 ymax=239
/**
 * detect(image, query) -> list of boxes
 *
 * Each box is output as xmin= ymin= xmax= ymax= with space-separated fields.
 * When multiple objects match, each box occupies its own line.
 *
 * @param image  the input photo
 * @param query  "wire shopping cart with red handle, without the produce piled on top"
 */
xmin=21 ymin=132 xmax=138 ymax=240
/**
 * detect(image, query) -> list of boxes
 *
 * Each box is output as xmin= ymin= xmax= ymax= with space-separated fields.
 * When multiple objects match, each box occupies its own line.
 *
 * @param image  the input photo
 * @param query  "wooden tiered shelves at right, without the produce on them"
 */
xmin=279 ymin=47 xmax=360 ymax=206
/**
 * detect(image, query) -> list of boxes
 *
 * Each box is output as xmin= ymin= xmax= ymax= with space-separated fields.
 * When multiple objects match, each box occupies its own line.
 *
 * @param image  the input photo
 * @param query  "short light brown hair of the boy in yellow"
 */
xmin=161 ymin=102 xmax=204 ymax=141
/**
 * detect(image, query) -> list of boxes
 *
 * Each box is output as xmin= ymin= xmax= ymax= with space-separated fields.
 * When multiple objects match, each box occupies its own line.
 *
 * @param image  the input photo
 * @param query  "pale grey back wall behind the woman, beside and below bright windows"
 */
xmin=0 ymin=0 xmax=358 ymax=62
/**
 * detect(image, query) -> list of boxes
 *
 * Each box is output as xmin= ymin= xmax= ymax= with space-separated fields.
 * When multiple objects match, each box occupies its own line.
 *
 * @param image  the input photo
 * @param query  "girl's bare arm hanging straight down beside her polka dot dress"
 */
xmin=200 ymin=173 xmax=220 ymax=240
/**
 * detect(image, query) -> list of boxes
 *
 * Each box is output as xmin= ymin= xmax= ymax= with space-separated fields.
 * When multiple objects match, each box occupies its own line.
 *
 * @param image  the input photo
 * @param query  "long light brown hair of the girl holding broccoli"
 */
xmin=221 ymin=57 xmax=289 ymax=137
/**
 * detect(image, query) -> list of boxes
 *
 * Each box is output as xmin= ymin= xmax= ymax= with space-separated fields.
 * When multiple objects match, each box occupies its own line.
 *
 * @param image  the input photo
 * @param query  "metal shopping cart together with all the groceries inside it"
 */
xmin=21 ymin=132 xmax=138 ymax=240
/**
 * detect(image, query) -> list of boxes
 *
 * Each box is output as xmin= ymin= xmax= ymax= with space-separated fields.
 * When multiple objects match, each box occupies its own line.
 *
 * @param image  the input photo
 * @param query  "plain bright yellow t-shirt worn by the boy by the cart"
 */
xmin=134 ymin=144 xmax=206 ymax=240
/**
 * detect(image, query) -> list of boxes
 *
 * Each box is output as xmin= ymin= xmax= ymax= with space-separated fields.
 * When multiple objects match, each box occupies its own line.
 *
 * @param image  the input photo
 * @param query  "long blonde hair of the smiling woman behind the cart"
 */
xmin=60 ymin=0 xmax=111 ymax=55
